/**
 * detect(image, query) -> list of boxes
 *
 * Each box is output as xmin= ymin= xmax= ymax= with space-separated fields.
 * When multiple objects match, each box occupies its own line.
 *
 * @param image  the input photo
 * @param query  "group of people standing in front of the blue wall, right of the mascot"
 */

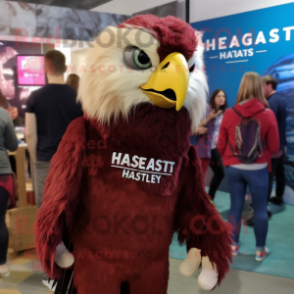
xmin=191 ymin=72 xmax=286 ymax=261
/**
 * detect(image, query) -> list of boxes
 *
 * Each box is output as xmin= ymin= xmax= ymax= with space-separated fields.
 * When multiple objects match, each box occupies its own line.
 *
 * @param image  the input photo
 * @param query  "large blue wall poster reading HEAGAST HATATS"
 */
xmin=191 ymin=3 xmax=294 ymax=205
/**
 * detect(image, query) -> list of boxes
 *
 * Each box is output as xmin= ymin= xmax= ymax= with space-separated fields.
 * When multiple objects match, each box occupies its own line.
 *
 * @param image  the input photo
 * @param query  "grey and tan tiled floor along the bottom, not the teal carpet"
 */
xmin=0 ymin=250 xmax=294 ymax=294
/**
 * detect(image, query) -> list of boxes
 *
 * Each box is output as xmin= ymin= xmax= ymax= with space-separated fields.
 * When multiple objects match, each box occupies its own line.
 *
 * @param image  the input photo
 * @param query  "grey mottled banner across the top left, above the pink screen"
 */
xmin=0 ymin=1 xmax=129 ymax=41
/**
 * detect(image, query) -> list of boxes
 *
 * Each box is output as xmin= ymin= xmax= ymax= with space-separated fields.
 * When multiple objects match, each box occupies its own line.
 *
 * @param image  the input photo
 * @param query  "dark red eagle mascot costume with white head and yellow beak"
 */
xmin=36 ymin=15 xmax=231 ymax=294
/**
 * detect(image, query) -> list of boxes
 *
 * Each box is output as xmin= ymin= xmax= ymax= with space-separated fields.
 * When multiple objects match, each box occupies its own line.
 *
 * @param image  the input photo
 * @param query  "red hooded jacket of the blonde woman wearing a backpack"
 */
xmin=217 ymin=98 xmax=279 ymax=171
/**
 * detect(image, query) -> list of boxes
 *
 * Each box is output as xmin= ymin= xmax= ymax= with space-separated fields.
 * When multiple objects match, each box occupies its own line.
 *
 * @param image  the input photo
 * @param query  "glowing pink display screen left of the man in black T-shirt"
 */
xmin=17 ymin=55 xmax=46 ymax=86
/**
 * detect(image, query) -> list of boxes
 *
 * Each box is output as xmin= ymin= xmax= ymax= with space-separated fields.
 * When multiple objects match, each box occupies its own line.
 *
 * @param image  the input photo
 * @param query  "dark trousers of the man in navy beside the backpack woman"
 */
xmin=268 ymin=155 xmax=286 ymax=199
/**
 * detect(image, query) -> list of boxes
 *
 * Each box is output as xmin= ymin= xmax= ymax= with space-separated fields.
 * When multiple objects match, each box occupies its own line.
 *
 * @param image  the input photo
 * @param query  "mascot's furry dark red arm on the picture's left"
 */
xmin=36 ymin=118 xmax=85 ymax=279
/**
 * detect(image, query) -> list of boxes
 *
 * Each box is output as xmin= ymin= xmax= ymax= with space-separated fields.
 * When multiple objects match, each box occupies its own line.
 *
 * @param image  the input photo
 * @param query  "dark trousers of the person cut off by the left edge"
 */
xmin=0 ymin=186 xmax=9 ymax=265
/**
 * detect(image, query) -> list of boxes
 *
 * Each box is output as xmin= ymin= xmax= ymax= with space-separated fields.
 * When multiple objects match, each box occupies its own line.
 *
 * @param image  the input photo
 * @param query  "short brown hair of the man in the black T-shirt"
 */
xmin=45 ymin=50 xmax=66 ymax=76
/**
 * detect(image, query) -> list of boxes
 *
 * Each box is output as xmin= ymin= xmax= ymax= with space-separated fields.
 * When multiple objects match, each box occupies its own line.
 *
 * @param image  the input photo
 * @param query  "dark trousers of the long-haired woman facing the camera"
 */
xmin=208 ymin=148 xmax=225 ymax=200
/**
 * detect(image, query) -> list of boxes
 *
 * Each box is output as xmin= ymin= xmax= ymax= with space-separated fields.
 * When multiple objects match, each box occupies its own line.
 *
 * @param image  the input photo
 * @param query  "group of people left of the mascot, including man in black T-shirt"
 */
xmin=0 ymin=50 xmax=83 ymax=286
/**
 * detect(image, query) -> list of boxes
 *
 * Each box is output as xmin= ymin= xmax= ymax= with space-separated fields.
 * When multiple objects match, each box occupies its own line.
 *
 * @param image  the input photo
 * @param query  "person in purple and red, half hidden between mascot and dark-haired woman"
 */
xmin=190 ymin=105 xmax=214 ymax=179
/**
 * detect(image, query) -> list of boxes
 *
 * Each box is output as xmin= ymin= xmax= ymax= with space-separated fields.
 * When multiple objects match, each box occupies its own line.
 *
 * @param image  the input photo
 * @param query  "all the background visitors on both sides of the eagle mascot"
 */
xmin=0 ymin=50 xmax=286 ymax=285
